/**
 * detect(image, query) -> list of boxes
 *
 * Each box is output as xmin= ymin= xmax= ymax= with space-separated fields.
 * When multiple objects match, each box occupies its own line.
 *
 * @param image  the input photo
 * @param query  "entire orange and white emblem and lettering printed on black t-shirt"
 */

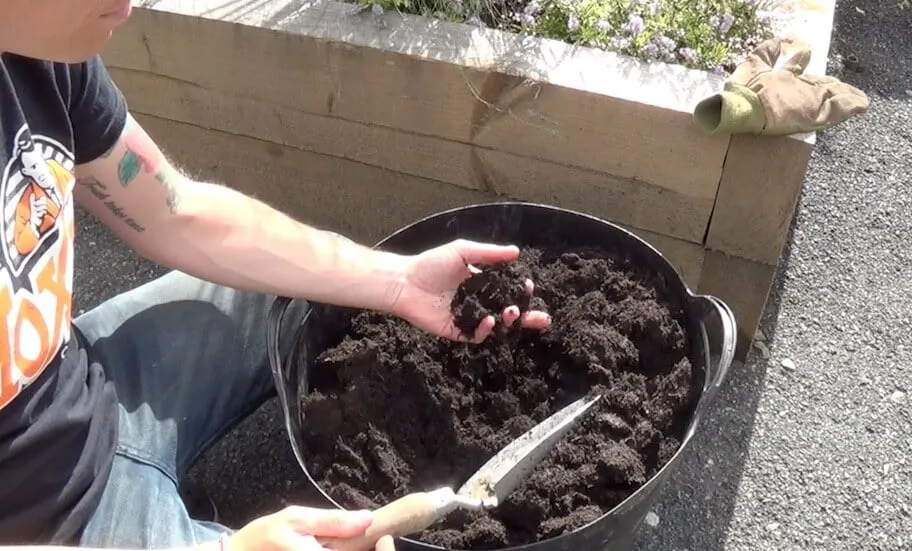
xmin=0 ymin=127 xmax=75 ymax=410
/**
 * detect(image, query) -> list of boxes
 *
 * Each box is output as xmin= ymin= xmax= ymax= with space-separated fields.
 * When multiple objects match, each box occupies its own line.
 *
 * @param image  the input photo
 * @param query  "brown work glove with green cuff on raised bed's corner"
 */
xmin=693 ymin=38 xmax=868 ymax=136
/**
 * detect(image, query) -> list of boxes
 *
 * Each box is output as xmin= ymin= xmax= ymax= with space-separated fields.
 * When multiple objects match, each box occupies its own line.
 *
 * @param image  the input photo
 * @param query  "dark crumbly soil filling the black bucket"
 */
xmin=302 ymin=249 xmax=699 ymax=549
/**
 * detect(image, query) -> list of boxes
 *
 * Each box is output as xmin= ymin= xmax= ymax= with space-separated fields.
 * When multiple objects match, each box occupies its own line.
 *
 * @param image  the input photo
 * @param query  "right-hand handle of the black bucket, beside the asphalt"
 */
xmin=694 ymin=295 xmax=738 ymax=404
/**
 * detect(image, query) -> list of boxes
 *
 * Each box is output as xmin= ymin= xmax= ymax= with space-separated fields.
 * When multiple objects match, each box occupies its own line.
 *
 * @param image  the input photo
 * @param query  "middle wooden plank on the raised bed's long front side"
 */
xmin=110 ymin=68 xmax=715 ymax=243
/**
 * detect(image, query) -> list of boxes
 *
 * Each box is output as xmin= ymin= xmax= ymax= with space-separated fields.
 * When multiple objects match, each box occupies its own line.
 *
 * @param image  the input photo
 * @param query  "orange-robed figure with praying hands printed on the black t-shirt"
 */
xmin=13 ymin=159 xmax=72 ymax=255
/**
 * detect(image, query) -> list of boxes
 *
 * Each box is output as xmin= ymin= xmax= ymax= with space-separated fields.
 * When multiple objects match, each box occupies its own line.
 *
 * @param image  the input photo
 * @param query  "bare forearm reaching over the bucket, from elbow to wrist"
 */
xmin=141 ymin=182 xmax=407 ymax=311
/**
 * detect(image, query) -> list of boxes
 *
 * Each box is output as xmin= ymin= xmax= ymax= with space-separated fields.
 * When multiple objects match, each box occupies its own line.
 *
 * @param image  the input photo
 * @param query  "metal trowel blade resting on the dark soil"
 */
xmin=457 ymin=396 xmax=601 ymax=507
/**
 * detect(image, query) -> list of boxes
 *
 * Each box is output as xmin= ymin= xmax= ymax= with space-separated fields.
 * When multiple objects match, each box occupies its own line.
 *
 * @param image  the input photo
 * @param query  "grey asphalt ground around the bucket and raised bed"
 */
xmin=76 ymin=0 xmax=912 ymax=551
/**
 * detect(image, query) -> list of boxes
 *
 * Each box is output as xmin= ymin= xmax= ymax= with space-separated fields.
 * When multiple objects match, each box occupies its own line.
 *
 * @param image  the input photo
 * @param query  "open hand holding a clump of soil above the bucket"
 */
xmin=393 ymin=239 xmax=551 ymax=343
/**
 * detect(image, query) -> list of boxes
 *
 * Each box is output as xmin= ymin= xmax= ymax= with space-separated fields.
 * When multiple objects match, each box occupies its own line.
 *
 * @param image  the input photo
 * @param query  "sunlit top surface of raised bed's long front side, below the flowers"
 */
xmin=128 ymin=0 xmax=723 ymax=114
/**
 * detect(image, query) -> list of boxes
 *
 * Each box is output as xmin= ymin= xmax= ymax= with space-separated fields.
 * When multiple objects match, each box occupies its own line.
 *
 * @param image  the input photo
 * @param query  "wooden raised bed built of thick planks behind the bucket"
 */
xmin=103 ymin=0 xmax=833 ymax=357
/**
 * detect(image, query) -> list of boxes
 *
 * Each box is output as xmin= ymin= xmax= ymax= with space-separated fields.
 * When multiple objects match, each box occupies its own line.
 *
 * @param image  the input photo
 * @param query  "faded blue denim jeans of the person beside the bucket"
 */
xmin=75 ymin=272 xmax=307 ymax=549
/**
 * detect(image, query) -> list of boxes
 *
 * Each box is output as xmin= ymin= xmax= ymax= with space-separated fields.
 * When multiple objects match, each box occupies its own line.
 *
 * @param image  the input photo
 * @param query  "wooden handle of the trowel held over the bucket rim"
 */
xmin=317 ymin=488 xmax=454 ymax=551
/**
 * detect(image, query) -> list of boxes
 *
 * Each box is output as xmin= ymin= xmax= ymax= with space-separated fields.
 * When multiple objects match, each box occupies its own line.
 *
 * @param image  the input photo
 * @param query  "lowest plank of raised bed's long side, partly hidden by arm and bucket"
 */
xmin=126 ymin=114 xmax=704 ymax=289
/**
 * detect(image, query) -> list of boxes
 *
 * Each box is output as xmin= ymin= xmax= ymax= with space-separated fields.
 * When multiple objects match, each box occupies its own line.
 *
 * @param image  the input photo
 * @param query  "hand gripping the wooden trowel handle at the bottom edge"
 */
xmin=226 ymin=506 xmax=396 ymax=551
